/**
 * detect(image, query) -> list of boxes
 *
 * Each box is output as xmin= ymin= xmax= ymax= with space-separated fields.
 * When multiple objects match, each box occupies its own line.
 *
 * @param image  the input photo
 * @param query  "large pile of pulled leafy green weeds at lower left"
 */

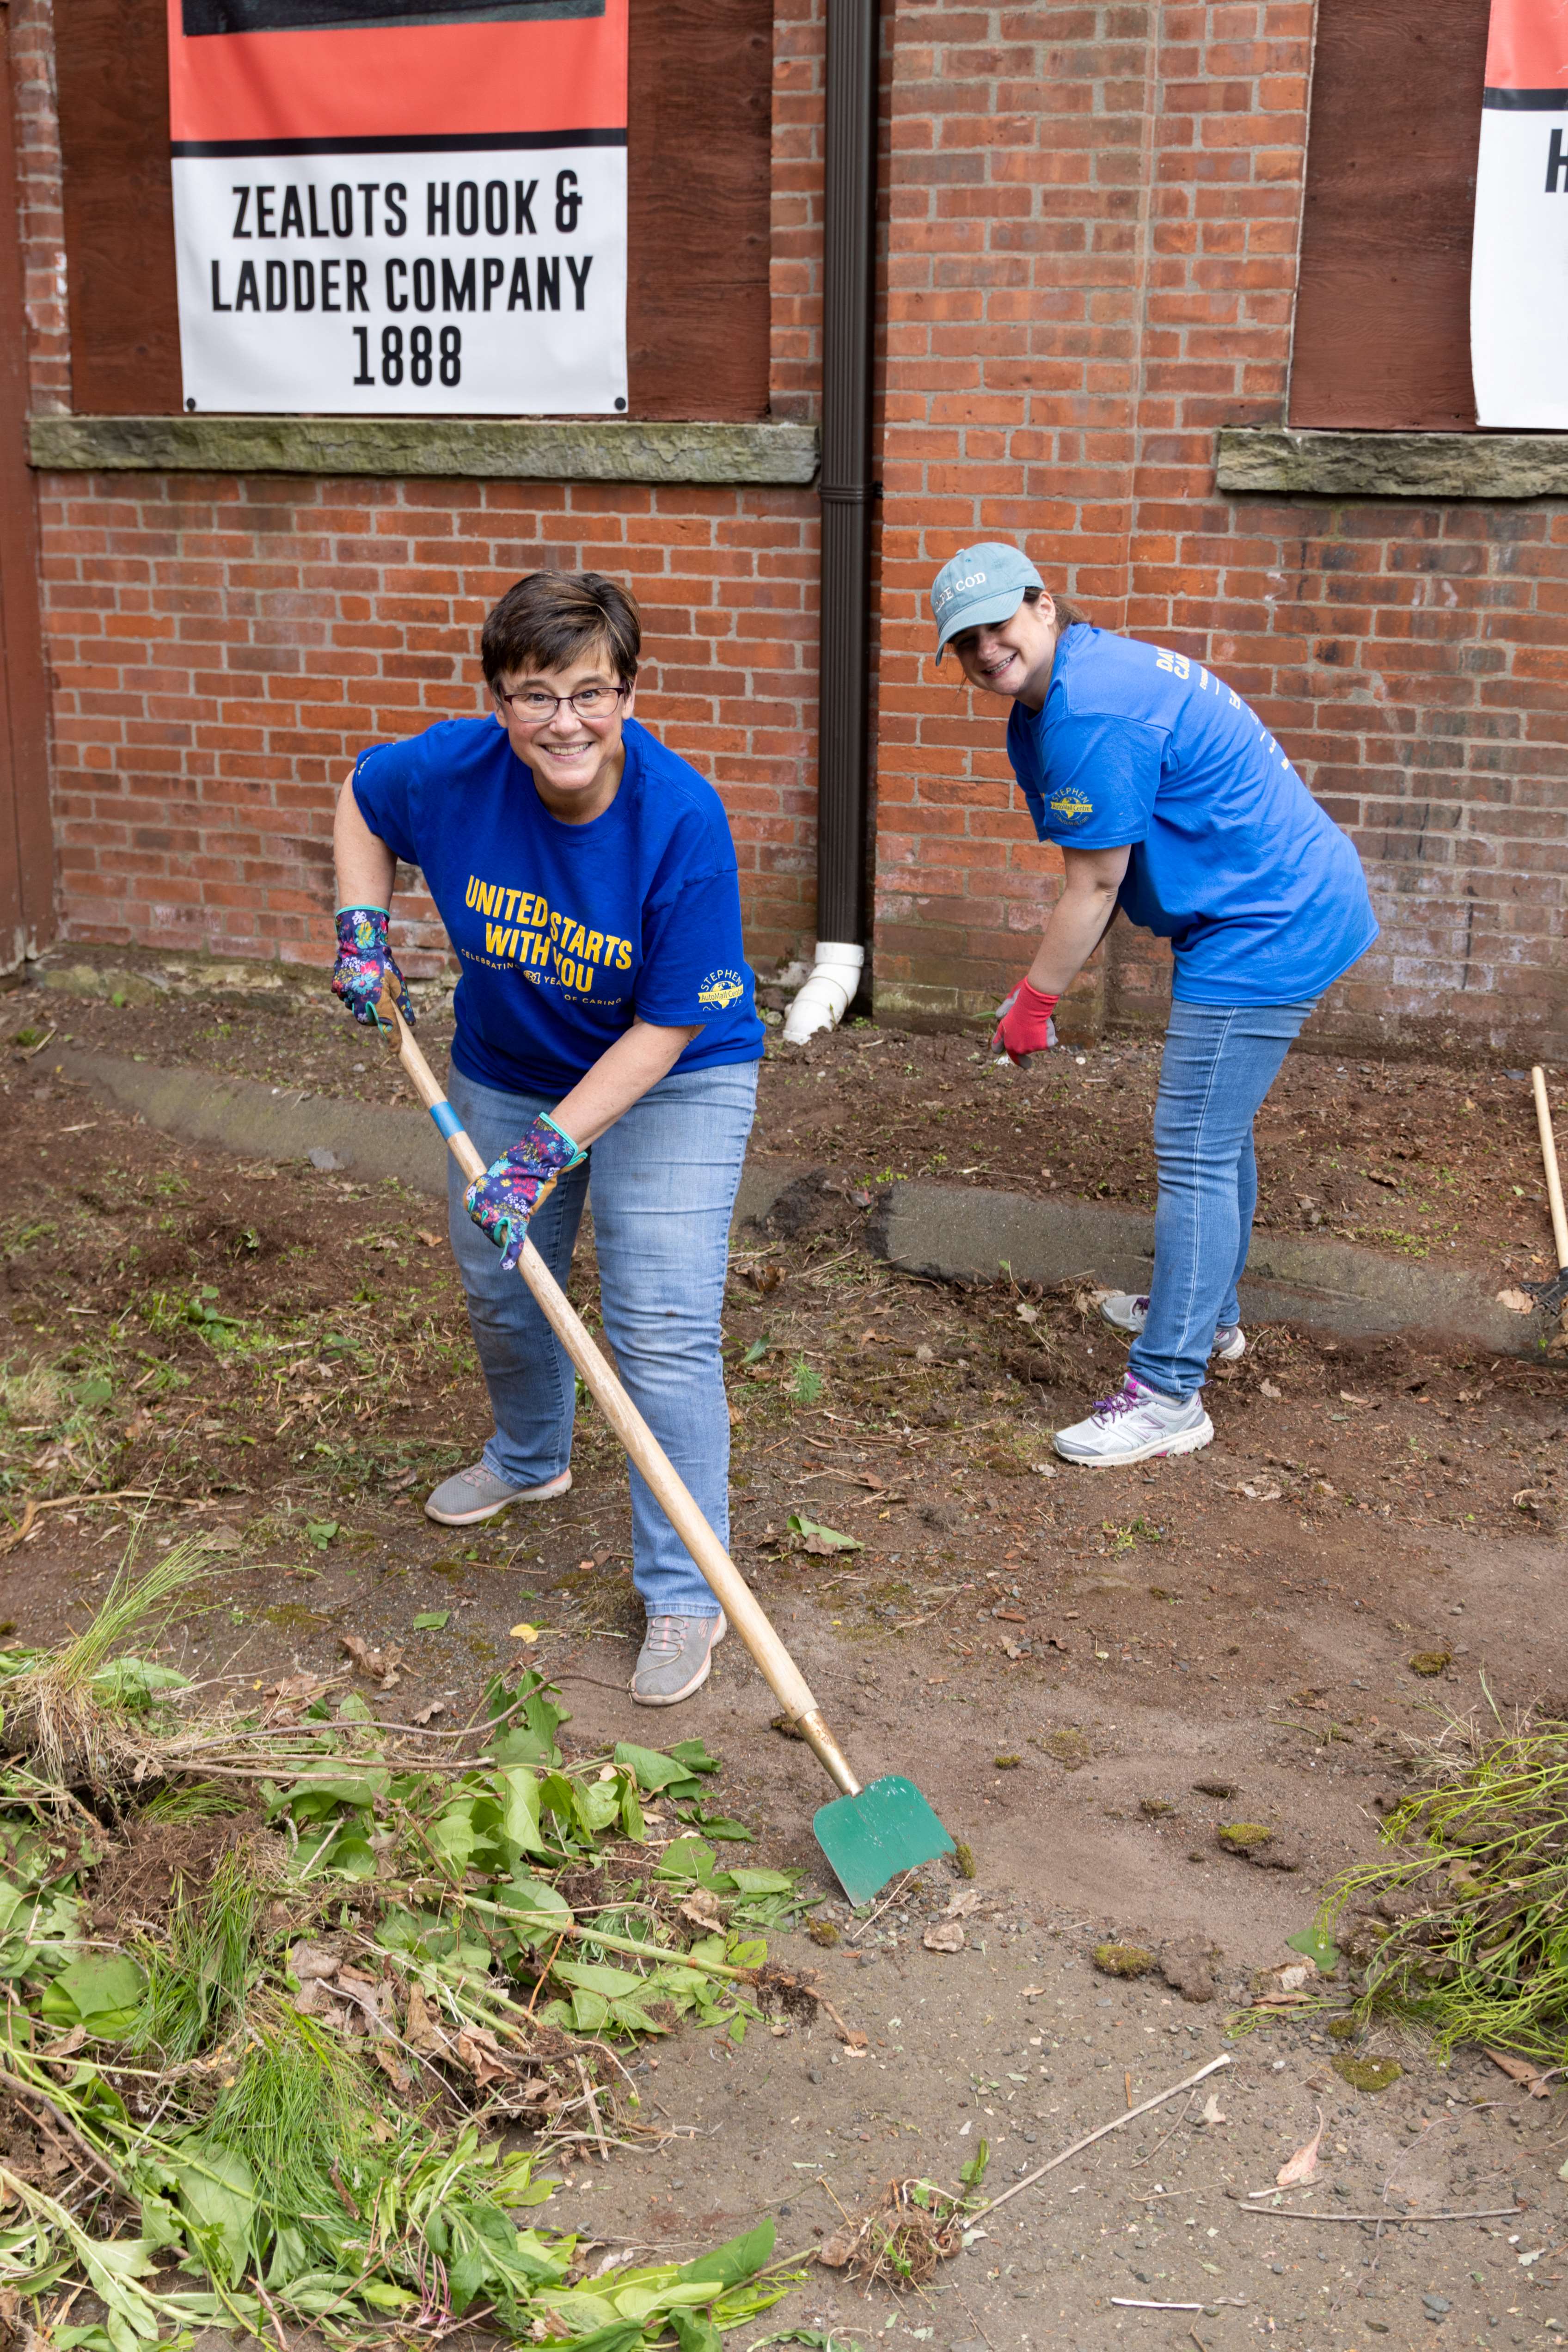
xmin=0 ymin=1552 xmax=818 ymax=2352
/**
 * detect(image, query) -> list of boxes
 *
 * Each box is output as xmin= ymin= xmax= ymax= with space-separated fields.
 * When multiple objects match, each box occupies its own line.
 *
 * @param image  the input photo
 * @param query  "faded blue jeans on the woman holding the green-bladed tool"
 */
xmin=447 ymin=1061 xmax=757 ymax=1616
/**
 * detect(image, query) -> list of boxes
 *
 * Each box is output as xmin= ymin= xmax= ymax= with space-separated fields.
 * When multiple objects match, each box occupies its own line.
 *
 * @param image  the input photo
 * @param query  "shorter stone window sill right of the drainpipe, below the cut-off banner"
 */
xmin=1215 ymin=426 xmax=1568 ymax=499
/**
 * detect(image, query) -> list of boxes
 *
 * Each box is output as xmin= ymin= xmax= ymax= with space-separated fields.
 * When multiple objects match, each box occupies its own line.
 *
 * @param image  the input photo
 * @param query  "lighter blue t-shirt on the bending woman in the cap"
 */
xmin=1006 ymin=621 xmax=1378 ymax=1004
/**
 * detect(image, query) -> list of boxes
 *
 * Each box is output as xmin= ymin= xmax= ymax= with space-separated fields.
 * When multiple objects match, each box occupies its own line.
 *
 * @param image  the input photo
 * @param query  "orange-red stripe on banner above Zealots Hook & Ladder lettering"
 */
xmin=169 ymin=0 xmax=628 ymax=141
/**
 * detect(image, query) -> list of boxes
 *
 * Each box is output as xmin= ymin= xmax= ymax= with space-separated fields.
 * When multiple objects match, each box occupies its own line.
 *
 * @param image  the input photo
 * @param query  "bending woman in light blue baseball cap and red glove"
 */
xmin=931 ymin=543 xmax=1378 ymax=1468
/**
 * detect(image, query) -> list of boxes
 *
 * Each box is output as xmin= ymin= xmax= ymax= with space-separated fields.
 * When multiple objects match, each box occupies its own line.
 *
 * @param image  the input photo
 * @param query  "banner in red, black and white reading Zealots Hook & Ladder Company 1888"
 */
xmin=167 ymin=0 xmax=628 ymax=416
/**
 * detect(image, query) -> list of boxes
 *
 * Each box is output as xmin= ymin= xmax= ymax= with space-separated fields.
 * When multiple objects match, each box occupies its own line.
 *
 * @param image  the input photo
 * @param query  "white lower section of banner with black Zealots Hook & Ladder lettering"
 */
xmin=174 ymin=146 xmax=625 ymax=416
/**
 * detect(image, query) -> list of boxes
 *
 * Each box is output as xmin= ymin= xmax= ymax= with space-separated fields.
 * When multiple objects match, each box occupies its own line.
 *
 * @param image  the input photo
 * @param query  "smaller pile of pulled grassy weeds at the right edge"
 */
xmin=1319 ymin=1721 xmax=1568 ymax=2067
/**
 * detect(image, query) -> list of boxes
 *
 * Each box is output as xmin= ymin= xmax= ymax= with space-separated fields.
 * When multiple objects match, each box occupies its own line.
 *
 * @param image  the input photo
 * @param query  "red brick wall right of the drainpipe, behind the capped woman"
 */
xmin=877 ymin=0 xmax=1568 ymax=1049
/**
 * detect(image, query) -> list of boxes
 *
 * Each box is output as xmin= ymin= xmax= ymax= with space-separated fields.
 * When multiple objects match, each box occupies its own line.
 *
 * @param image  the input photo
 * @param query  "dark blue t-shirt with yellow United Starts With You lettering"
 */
xmin=355 ymin=720 xmax=762 ymax=1096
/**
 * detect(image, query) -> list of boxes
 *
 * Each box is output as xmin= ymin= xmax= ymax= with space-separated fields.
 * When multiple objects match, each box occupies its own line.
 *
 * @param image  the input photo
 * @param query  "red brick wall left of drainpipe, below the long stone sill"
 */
xmin=43 ymin=475 xmax=816 ymax=962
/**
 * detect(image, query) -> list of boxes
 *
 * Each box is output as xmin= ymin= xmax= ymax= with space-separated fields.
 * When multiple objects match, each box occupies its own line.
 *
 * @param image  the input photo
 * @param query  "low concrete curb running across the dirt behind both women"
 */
xmin=54 ymin=1047 xmax=1549 ymax=1357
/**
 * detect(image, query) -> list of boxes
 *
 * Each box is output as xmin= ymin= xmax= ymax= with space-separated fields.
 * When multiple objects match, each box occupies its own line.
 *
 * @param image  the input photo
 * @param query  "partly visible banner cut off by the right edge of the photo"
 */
xmin=1469 ymin=0 xmax=1568 ymax=433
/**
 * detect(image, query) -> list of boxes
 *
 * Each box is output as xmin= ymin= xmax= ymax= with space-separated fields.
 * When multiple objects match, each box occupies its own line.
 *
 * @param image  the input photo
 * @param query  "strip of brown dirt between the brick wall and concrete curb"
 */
xmin=28 ymin=948 xmax=1568 ymax=1282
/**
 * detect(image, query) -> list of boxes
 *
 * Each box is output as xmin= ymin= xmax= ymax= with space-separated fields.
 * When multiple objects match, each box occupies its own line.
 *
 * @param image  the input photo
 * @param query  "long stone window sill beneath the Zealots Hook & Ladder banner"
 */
xmin=28 ymin=416 xmax=818 ymax=489
